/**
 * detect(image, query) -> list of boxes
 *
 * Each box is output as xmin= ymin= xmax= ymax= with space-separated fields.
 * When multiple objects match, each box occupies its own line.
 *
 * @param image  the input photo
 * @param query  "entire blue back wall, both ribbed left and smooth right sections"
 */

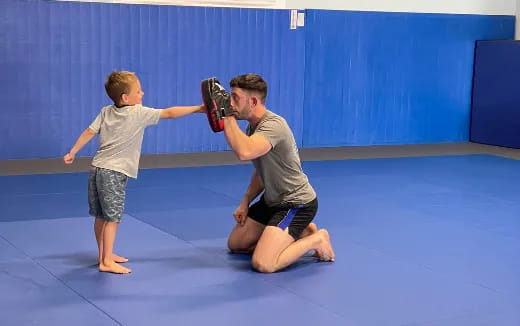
xmin=0 ymin=0 xmax=514 ymax=160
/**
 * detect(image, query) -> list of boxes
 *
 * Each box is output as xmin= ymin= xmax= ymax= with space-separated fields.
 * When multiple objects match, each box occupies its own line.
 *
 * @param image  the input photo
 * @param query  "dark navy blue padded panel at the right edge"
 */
xmin=470 ymin=41 xmax=520 ymax=148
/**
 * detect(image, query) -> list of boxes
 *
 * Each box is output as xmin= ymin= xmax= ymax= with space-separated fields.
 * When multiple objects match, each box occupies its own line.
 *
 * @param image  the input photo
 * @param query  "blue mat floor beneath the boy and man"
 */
xmin=0 ymin=155 xmax=520 ymax=326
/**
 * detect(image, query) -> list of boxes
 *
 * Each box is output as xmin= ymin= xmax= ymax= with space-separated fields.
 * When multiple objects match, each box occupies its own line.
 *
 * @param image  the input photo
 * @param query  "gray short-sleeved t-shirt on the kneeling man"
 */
xmin=247 ymin=110 xmax=316 ymax=206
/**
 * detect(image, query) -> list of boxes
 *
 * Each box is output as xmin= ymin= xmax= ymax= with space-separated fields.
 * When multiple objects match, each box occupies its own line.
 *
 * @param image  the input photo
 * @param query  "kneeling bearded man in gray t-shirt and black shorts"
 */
xmin=218 ymin=74 xmax=334 ymax=273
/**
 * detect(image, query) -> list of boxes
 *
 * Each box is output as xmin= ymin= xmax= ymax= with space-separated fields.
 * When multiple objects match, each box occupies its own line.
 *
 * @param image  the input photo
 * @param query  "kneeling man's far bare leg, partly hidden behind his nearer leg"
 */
xmin=228 ymin=217 xmax=265 ymax=254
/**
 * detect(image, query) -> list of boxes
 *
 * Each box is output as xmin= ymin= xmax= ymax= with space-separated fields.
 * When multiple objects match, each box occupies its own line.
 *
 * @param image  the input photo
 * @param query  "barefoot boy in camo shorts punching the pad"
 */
xmin=63 ymin=71 xmax=205 ymax=274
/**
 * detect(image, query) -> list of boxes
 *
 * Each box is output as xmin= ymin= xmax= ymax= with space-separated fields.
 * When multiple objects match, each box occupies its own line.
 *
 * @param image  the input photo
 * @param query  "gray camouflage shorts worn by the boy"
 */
xmin=88 ymin=166 xmax=128 ymax=223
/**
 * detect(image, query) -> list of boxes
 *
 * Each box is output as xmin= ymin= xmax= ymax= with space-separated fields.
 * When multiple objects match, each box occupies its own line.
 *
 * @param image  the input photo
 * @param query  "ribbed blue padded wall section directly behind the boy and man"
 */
xmin=0 ymin=0 xmax=305 ymax=160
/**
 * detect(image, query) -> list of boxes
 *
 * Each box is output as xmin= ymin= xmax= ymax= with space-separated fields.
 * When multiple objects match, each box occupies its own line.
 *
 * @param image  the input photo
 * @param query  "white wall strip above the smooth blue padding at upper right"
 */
xmin=285 ymin=0 xmax=520 ymax=15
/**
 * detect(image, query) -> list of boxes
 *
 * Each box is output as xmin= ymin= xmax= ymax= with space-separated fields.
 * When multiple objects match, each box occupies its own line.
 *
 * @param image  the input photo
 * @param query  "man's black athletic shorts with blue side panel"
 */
xmin=247 ymin=196 xmax=318 ymax=240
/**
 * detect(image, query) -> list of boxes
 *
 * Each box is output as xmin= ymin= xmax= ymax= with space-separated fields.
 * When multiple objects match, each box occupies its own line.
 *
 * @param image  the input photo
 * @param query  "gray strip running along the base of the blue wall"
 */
xmin=0 ymin=143 xmax=520 ymax=175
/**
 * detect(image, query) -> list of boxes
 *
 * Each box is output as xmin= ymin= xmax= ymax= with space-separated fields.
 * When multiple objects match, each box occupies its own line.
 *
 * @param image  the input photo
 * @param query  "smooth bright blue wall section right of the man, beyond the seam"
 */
xmin=303 ymin=10 xmax=514 ymax=147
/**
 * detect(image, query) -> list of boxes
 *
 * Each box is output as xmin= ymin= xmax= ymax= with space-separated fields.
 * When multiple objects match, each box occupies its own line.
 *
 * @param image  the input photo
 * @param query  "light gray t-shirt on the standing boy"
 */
xmin=89 ymin=104 xmax=161 ymax=178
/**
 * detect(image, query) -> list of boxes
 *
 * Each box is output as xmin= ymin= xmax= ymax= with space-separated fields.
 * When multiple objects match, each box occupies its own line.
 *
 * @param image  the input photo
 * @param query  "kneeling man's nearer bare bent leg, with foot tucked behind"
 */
xmin=253 ymin=226 xmax=334 ymax=273
